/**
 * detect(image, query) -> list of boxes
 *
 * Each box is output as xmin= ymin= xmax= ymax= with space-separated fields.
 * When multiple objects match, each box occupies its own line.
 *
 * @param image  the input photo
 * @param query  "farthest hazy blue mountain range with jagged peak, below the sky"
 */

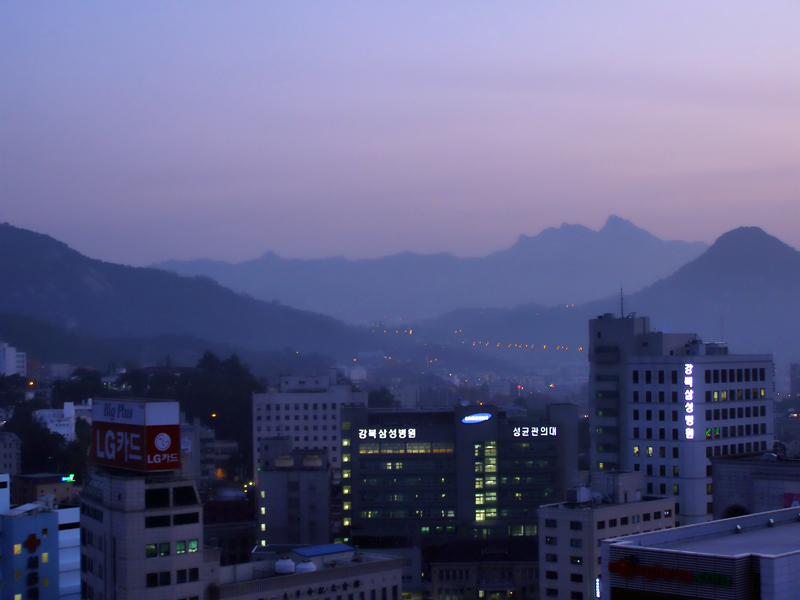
xmin=153 ymin=215 xmax=707 ymax=323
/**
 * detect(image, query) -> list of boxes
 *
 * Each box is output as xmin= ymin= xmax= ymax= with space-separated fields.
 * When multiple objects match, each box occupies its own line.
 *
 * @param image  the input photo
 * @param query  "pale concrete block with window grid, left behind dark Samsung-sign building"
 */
xmin=253 ymin=369 xmax=367 ymax=473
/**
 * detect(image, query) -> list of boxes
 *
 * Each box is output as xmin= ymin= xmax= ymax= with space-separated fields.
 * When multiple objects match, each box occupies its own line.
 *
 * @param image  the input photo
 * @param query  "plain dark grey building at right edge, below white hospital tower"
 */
xmin=711 ymin=452 xmax=800 ymax=519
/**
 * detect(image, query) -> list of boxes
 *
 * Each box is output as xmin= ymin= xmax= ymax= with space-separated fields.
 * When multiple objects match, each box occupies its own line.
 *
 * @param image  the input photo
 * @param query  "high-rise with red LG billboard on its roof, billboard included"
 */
xmin=80 ymin=400 xmax=206 ymax=600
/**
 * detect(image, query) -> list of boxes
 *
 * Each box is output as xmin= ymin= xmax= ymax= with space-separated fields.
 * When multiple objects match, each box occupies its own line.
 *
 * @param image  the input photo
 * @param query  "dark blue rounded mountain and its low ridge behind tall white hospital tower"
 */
xmin=415 ymin=227 xmax=800 ymax=368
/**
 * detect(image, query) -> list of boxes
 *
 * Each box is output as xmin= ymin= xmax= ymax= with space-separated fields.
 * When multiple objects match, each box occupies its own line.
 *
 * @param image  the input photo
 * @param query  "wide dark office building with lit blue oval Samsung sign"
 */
xmin=342 ymin=404 xmax=578 ymax=547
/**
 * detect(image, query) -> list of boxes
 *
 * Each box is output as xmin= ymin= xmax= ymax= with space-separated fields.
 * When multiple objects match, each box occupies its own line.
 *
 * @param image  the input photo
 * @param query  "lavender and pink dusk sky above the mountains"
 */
xmin=0 ymin=0 xmax=800 ymax=265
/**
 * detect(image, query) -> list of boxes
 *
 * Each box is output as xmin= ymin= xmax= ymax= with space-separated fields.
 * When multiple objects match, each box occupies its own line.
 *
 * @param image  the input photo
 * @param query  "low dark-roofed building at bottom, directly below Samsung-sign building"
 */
xmin=430 ymin=538 xmax=539 ymax=600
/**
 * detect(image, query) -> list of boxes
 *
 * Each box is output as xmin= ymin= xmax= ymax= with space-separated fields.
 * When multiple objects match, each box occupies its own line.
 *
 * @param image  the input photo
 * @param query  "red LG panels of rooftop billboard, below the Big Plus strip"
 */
xmin=92 ymin=422 xmax=181 ymax=471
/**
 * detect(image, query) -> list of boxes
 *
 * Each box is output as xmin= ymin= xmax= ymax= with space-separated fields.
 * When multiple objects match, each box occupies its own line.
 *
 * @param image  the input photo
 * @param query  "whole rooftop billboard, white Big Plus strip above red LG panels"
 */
xmin=92 ymin=399 xmax=181 ymax=472
